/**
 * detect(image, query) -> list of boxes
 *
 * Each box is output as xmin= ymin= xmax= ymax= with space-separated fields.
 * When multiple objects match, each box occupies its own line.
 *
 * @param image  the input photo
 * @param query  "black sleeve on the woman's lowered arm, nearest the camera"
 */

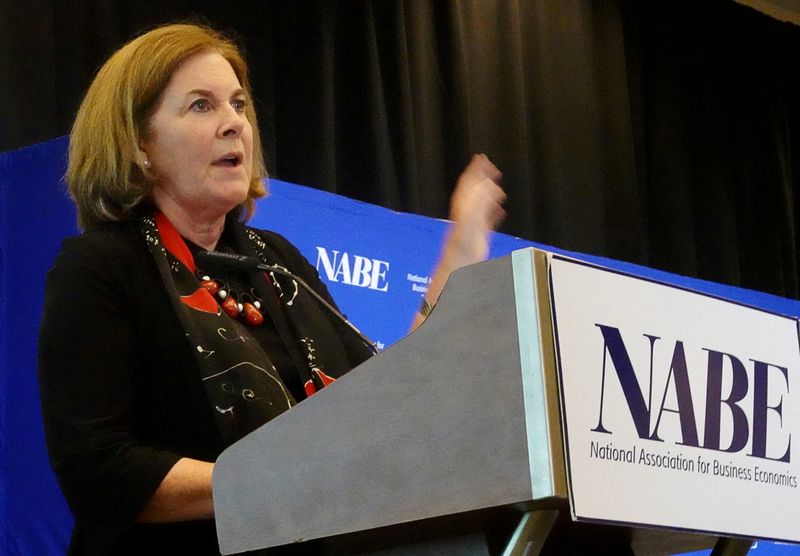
xmin=38 ymin=236 xmax=180 ymax=525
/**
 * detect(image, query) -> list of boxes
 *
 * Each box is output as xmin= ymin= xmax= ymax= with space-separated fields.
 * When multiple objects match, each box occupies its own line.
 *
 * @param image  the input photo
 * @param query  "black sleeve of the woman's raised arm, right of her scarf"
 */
xmin=261 ymin=231 xmax=373 ymax=368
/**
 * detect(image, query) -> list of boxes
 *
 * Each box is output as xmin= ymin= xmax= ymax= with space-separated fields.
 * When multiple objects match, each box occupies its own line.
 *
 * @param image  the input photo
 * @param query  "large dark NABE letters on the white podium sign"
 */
xmin=591 ymin=324 xmax=797 ymax=474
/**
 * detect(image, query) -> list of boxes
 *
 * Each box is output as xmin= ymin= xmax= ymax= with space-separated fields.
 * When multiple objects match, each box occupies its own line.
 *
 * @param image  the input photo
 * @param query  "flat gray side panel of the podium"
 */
xmin=214 ymin=257 xmax=564 ymax=554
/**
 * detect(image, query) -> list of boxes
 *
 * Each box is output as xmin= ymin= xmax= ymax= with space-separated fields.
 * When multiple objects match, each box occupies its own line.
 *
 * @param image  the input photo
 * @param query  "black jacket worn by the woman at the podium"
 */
xmin=39 ymin=222 xmax=369 ymax=554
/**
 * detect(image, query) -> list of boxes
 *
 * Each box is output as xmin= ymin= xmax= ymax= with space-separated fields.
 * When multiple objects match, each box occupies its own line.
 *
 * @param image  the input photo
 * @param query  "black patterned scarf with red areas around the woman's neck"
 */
xmin=140 ymin=212 xmax=369 ymax=444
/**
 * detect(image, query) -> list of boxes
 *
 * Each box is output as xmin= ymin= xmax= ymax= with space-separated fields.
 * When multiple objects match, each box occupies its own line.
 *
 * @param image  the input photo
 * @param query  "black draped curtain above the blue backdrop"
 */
xmin=0 ymin=0 xmax=800 ymax=297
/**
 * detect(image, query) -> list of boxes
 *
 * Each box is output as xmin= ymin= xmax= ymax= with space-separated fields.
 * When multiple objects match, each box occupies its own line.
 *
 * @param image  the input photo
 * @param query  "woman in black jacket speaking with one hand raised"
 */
xmin=39 ymin=25 xmax=504 ymax=554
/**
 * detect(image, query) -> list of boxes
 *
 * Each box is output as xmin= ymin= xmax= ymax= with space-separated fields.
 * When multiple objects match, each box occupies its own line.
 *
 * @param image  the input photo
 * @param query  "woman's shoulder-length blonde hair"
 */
xmin=66 ymin=23 xmax=266 ymax=229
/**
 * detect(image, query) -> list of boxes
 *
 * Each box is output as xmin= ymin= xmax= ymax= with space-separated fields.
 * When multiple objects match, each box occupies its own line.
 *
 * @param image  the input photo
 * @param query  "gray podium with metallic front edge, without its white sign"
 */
xmin=213 ymin=250 xmax=792 ymax=554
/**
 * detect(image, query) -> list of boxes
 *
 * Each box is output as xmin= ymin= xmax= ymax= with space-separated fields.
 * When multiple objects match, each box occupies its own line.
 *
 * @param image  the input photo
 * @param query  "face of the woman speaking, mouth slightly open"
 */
xmin=142 ymin=51 xmax=253 ymax=221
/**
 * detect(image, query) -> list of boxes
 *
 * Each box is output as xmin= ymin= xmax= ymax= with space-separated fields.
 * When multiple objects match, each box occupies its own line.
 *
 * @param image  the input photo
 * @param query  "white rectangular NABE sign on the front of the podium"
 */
xmin=550 ymin=256 xmax=800 ymax=541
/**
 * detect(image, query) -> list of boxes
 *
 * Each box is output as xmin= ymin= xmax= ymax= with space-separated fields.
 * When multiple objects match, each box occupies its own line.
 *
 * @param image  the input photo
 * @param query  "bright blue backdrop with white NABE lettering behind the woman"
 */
xmin=0 ymin=138 xmax=800 ymax=556
